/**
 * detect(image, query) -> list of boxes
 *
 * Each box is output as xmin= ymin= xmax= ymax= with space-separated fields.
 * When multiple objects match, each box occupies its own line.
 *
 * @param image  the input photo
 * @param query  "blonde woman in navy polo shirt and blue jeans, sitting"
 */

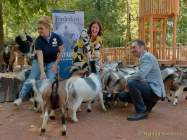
xmin=14 ymin=16 xmax=64 ymax=106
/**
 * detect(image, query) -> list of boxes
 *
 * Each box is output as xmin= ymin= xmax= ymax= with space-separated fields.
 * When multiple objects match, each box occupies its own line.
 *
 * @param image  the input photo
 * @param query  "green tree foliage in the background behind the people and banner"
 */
xmin=1 ymin=0 xmax=187 ymax=47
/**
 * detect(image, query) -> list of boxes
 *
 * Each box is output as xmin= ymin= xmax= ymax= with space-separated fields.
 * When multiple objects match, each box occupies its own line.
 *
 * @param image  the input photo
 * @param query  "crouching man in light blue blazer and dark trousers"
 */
xmin=118 ymin=40 xmax=165 ymax=121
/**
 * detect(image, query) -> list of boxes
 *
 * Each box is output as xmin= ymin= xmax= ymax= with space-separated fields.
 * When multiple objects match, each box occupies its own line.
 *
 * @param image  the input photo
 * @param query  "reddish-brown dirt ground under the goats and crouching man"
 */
xmin=0 ymin=94 xmax=187 ymax=140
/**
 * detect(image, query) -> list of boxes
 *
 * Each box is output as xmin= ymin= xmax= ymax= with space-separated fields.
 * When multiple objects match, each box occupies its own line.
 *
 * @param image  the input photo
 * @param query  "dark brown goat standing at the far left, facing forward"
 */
xmin=3 ymin=45 xmax=16 ymax=72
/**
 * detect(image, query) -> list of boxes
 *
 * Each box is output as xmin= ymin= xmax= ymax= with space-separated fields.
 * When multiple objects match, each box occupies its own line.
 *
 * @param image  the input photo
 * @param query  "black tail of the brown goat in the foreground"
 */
xmin=50 ymin=79 xmax=59 ymax=109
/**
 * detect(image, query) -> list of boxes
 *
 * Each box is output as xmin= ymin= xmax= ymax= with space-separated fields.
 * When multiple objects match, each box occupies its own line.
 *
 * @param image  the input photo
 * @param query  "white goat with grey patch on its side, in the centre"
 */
xmin=65 ymin=73 xmax=106 ymax=122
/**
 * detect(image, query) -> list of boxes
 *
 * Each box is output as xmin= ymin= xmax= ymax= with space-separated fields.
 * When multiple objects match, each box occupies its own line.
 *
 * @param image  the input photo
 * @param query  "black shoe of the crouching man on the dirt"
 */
xmin=127 ymin=112 xmax=148 ymax=121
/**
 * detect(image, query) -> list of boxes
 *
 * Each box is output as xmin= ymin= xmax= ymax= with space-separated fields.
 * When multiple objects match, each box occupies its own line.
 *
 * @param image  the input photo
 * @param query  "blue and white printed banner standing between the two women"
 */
xmin=52 ymin=10 xmax=84 ymax=79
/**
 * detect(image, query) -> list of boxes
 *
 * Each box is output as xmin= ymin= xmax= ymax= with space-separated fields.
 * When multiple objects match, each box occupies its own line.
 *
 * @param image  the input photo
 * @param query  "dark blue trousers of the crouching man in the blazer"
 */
xmin=118 ymin=79 xmax=160 ymax=113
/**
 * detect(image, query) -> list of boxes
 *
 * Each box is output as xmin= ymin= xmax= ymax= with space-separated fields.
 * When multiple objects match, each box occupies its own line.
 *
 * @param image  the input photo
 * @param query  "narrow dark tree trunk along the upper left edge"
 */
xmin=0 ymin=1 xmax=4 ymax=51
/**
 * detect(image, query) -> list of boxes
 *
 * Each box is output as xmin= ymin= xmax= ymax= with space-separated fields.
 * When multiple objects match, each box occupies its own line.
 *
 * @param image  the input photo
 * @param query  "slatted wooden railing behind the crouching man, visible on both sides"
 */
xmin=101 ymin=46 xmax=187 ymax=66
